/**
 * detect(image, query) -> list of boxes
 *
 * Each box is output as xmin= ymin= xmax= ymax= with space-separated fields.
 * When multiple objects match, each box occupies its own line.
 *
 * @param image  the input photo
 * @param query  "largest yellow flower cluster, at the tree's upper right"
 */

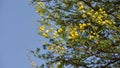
xmin=87 ymin=8 xmax=114 ymax=25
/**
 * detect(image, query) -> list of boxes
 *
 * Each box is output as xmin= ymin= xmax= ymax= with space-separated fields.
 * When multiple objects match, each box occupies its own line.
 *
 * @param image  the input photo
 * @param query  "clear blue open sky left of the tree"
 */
xmin=0 ymin=0 xmax=45 ymax=68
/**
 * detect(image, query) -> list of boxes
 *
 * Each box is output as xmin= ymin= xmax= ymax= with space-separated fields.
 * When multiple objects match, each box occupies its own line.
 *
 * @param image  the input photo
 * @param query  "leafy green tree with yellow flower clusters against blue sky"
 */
xmin=31 ymin=0 xmax=120 ymax=68
